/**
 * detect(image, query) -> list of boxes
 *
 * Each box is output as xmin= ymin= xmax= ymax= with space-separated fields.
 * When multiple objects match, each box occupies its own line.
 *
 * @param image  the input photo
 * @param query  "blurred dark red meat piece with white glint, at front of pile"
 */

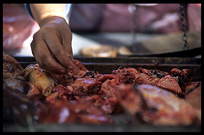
xmin=39 ymin=101 xmax=114 ymax=124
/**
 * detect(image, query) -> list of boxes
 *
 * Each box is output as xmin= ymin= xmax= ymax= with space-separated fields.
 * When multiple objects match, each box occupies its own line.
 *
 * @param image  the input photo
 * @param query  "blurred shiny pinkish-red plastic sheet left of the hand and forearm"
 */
xmin=3 ymin=4 xmax=35 ymax=54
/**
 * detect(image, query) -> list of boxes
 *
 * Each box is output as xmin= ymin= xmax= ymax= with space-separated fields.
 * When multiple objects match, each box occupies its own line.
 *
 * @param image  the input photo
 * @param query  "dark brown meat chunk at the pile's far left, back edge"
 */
xmin=3 ymin=54 xmax=23 ymax=79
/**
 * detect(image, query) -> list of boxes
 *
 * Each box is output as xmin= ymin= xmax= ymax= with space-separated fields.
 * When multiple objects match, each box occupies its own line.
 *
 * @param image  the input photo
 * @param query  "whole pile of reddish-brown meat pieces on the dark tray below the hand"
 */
xmin=3 ymin=55 xmax=201 ymax=125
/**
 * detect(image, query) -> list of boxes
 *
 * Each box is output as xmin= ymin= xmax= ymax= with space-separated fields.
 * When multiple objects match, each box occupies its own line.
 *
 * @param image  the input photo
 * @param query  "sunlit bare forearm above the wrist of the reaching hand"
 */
xmin=30 ymin=4 xmax=66 ymax=27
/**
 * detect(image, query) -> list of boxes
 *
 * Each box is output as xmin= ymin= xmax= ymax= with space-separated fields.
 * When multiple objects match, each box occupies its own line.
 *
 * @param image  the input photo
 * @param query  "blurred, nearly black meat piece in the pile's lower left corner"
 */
xmin=3 ymin=80 xmax=34 ymax=126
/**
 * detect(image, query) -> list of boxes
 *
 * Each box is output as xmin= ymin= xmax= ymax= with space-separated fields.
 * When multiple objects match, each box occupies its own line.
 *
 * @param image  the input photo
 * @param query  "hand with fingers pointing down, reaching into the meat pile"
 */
xmin=31 ymin=16 xmax=74 ymax=74
